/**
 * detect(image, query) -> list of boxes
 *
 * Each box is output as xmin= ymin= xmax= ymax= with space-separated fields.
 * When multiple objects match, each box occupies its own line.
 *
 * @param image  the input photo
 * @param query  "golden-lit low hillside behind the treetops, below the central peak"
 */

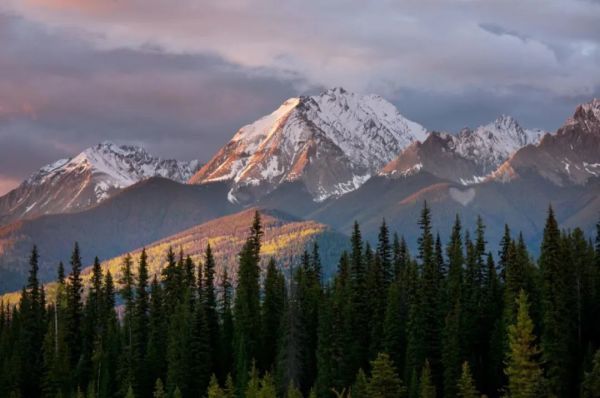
xmin=1 ymin=208 xmax=347 ymax=303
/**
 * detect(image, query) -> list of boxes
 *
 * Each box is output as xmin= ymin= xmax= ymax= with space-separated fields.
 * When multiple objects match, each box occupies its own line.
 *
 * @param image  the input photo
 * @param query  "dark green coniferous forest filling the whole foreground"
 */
xmin=0 ymin=204 xmax=600 ymax=398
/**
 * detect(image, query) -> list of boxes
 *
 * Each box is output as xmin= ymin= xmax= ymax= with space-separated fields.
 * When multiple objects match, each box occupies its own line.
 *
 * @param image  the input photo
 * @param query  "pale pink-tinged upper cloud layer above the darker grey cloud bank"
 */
xmin=5 ymin=0 xmax=600 ymax=95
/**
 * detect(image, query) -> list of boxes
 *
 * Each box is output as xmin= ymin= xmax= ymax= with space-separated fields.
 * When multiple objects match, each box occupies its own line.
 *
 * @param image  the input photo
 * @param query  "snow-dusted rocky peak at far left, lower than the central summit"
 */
xmin=0 ymin=142 xmax=200 ymax=225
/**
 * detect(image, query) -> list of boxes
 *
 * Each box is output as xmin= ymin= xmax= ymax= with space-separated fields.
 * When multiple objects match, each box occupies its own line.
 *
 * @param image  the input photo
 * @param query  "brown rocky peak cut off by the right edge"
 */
xmin=494 ymin=99 xmax=600 ymax=186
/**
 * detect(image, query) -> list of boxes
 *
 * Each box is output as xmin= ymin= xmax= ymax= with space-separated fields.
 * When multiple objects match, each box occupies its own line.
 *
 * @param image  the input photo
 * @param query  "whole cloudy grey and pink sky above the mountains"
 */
xmin=0 ymin=0 xmax=600 ymax=193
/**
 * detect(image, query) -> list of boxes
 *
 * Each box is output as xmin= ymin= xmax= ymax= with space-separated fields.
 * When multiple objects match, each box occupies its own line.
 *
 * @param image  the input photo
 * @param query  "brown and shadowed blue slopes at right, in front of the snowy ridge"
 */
xmin=324 ymin=100 xmax=600 ymax=252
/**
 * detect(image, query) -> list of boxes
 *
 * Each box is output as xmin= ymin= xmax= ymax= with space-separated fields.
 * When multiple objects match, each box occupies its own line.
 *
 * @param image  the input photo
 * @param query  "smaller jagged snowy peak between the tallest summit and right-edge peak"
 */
xmin=380 ymin=116 xmax=544 ymax=185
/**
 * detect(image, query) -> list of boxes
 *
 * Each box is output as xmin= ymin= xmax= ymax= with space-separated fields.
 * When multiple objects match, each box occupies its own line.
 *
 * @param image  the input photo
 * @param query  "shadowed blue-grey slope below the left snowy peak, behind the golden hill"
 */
xmin=0 ymin=177 xmax=239 ymax=291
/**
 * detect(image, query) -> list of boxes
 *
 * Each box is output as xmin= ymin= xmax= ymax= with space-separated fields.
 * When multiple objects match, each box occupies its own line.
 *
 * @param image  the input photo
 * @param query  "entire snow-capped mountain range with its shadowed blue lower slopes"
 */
xmin=0 ymin=88 xmax=600 ymax=291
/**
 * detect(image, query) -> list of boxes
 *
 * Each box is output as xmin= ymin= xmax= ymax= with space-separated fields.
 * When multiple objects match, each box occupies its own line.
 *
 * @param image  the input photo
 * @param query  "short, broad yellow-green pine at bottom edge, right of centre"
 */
xmin=367 ymin=353 xmax=406 ymax=398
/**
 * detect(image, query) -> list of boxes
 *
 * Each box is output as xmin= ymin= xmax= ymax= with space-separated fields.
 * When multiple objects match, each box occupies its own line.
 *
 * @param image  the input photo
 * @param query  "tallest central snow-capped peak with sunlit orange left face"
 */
xmin=190 ymin=88 xmax=426 ymax=203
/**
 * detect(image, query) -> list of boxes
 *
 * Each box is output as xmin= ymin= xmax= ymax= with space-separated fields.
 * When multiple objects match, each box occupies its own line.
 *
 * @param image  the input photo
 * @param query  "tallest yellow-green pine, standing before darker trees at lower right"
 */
xmin=505 ymin=290 xmax=543 ymax=398
